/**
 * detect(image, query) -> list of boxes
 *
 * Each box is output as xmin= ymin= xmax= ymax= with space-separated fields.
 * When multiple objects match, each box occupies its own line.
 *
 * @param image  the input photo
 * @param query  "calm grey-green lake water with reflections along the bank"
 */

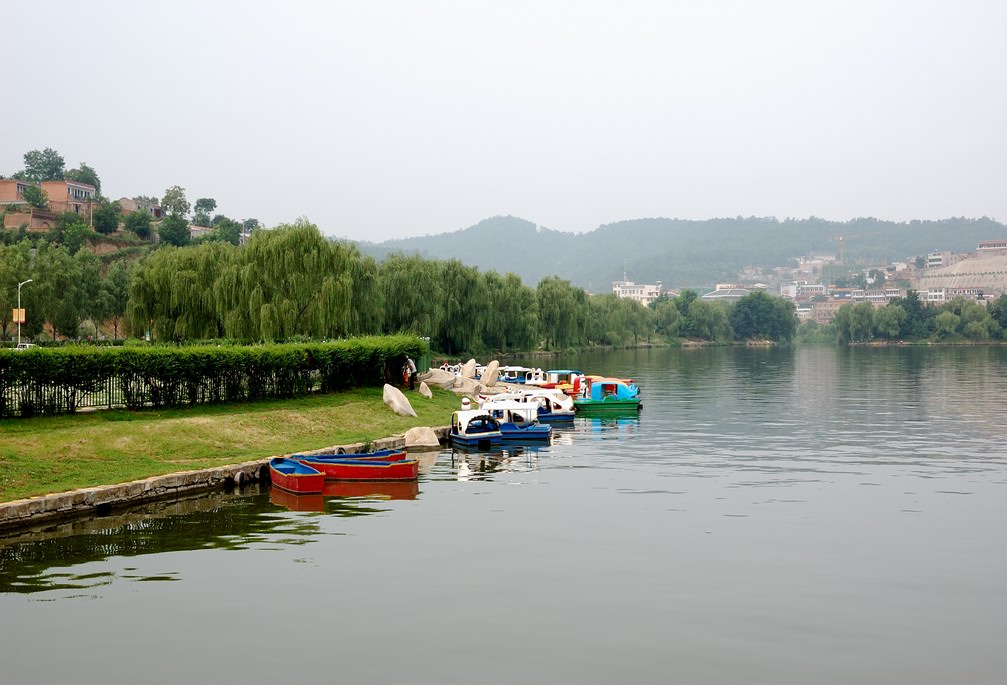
xmin=0 ymin=347 xmax=1007 ymax=685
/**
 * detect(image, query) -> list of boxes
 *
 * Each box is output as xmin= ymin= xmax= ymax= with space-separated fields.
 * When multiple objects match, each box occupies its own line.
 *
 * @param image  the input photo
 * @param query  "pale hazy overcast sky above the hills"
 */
xmin=0 ymin=0 xmax=1007 ymax=241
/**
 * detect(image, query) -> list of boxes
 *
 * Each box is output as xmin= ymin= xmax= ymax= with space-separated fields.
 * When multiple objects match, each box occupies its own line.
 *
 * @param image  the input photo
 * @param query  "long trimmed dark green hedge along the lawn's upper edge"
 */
xmin=0 ymin=335 xmax=427 ymax=417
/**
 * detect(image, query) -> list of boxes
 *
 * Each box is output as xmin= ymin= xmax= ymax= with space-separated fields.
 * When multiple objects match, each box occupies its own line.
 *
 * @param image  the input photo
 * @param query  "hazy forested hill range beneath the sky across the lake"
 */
xmin=358 ymin=217 xmax=1007 ymax=292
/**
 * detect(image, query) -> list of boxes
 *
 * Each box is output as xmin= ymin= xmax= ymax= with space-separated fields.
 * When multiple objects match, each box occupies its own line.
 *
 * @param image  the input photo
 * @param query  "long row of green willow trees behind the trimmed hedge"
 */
xmin=0 ymin=220 xmax=797 ymax=355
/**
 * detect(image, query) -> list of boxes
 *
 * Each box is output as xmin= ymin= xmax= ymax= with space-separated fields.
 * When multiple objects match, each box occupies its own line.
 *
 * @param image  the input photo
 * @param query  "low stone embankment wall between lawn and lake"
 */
xmin=0 ymin=427 xmax=448 ymax=534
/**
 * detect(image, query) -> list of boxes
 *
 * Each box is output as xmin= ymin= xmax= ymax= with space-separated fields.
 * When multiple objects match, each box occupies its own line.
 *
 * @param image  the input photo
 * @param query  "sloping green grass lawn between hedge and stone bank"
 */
xmin=0 ymin=388 xmax=459 ymax=502
